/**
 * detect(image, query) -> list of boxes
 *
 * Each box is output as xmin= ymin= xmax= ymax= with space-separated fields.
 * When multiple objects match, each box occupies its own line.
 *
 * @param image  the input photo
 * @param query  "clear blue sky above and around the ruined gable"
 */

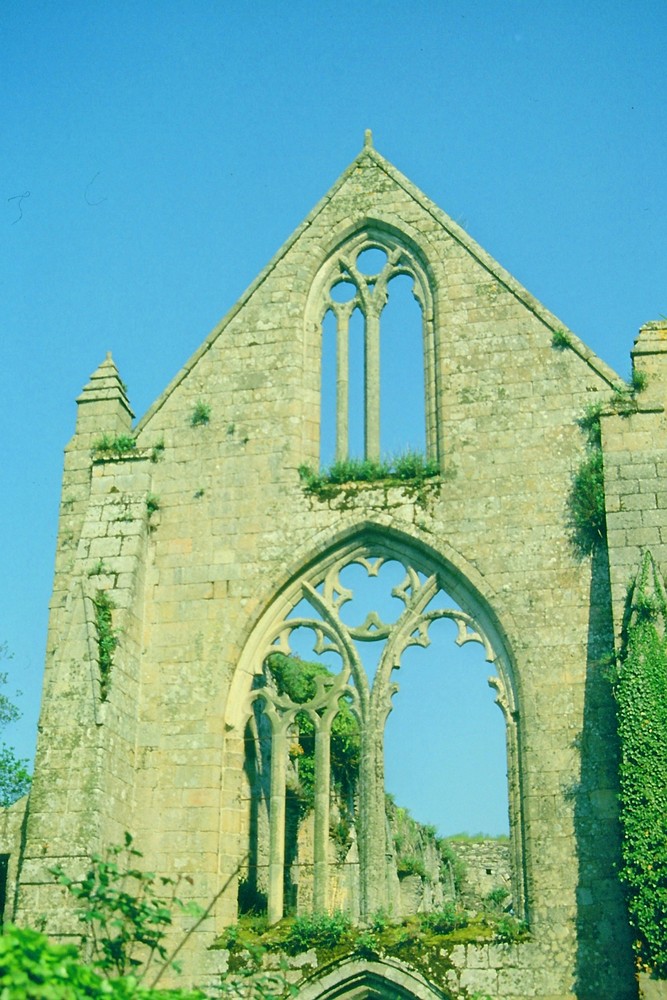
xmin=0 ymin=0 xmax=667 ymax=826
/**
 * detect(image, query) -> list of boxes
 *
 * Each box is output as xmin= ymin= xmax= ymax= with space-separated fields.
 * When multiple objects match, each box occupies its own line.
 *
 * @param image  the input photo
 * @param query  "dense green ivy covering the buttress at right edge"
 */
xmin=613 ymin=551 xmax=667 ymax=978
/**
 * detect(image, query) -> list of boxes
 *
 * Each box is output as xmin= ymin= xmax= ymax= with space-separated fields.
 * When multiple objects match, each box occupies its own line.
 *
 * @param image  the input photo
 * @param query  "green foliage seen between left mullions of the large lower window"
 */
xmin=266 ymin=653 xmax=361 ymax=811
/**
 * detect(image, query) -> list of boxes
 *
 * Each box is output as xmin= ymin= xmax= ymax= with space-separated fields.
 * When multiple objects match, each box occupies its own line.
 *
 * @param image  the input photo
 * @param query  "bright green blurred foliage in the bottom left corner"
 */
xmin=0 ymin=926 xmax=204 ymax=1000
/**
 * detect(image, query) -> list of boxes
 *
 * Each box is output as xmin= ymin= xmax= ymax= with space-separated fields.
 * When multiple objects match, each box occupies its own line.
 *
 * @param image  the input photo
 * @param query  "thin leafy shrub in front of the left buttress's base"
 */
xmin=51 ymin=833 xmax=201 ymax=982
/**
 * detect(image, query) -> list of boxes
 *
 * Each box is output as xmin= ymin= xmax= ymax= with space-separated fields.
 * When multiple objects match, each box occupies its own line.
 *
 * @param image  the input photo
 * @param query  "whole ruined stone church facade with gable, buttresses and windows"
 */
xmin=5 ymin=137 xmax=667 ymax=1000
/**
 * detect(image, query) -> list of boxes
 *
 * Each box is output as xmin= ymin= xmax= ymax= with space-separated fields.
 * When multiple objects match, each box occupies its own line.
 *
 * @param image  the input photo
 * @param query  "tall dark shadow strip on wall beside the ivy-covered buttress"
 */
xmin=572 ymin=545 xmax=637 ymax=1000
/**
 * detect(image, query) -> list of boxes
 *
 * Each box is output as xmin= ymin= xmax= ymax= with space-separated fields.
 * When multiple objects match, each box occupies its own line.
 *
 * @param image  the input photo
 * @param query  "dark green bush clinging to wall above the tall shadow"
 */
xmin=568 ymin=406 xmax=607 ymax=557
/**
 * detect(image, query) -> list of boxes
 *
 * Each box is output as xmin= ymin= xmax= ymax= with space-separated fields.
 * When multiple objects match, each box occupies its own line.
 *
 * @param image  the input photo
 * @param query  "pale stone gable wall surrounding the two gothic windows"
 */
xmin=11 ymin=155 xmax=648 ymax=1000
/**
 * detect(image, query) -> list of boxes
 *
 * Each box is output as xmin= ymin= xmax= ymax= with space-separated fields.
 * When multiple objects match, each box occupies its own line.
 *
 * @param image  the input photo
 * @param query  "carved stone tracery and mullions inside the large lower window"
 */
xmin=241 ymin=545 xmax=514 ymax=922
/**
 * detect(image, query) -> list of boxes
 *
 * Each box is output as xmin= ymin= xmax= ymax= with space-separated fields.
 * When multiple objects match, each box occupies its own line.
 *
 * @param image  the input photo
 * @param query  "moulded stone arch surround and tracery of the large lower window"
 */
xmin=225 ymin=525 xmax=524 ymax=921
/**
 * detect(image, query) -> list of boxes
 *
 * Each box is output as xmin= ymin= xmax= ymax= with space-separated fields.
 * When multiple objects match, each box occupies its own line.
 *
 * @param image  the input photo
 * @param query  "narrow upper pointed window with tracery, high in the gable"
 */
xmin=316 ymin=229 xmax=438 ymax=465
